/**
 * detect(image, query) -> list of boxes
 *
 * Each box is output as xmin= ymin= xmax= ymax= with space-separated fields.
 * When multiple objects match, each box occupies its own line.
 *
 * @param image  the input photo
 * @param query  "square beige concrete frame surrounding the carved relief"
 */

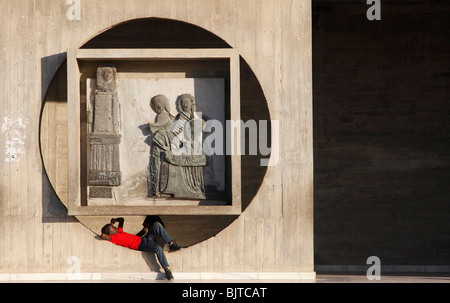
xmin=67 ymin=49 xmax=242 ymax=216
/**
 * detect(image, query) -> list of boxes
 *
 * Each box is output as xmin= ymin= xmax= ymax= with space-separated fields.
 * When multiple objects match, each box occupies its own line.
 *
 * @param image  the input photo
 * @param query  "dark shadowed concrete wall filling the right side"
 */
xmin=313 ymin=1 xmax=450 ymax=270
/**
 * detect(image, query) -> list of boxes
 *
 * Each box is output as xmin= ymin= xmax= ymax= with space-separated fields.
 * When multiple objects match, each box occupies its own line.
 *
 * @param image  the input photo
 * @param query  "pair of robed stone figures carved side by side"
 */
xmin=148 ymin=94 xmax=207 ymax=199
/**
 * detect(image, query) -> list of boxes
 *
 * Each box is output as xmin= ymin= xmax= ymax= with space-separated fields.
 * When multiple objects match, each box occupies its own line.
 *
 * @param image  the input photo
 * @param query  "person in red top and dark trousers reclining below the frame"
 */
xmin=102 ymin=218 xmax=181 ymax=280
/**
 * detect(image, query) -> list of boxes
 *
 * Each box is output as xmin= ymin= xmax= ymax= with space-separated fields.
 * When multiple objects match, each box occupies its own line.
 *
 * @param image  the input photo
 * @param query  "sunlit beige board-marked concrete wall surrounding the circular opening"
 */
xmin=0 ymin=0 xmax=314 ymax=273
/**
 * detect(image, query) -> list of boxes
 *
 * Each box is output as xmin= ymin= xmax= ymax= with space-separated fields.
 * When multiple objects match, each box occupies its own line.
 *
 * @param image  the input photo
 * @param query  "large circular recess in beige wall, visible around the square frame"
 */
xmin=40 ymin=18 xmax=270 ymax=247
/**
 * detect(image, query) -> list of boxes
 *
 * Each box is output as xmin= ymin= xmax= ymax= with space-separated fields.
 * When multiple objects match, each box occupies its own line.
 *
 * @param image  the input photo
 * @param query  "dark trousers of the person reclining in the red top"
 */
xmin=138 ymin=222 xmax=173 ymax=268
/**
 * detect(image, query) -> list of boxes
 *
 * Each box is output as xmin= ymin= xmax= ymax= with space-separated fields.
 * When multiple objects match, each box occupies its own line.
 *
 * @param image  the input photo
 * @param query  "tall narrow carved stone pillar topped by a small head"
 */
xmin=88 ymin=67 xmax=121 ymax=198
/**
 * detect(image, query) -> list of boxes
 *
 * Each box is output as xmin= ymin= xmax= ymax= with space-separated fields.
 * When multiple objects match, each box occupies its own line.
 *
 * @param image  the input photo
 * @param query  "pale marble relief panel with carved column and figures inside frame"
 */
xmin=86 ymin=77 xmax=227 ymax=206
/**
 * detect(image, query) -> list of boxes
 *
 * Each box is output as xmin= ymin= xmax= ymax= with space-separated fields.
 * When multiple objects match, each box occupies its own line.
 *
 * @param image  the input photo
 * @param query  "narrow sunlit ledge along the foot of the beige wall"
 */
xmin=0 ymin=272 xmax=316 ymax=282
